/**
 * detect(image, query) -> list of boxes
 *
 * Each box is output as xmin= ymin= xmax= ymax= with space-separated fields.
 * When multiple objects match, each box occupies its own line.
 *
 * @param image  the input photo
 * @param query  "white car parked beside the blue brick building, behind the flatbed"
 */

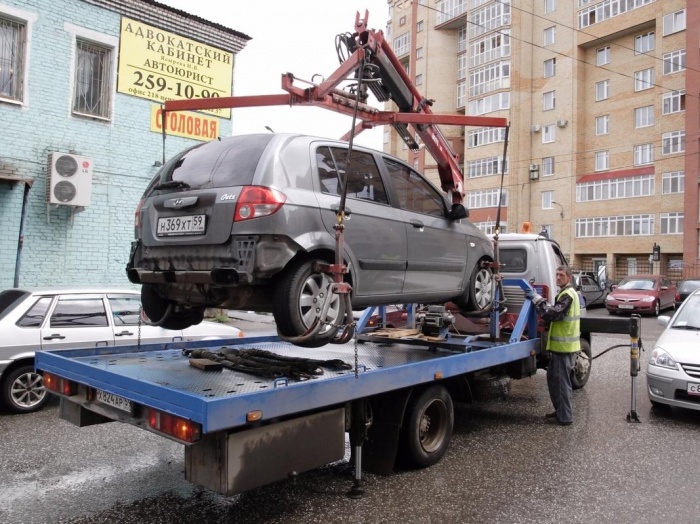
xmin=0 ymin=288 xmax=243 ymax=413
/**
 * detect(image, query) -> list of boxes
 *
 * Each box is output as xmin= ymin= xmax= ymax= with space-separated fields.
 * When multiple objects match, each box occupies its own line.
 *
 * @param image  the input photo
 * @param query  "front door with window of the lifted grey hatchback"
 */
xmin=384 ymin=158 xmax=469 ymax=294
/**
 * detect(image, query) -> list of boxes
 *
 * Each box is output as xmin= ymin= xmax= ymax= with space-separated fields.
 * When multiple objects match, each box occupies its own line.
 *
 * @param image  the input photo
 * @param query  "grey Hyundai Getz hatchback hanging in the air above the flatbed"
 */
xmin=127 ymin=133 xmax=493 ymax=346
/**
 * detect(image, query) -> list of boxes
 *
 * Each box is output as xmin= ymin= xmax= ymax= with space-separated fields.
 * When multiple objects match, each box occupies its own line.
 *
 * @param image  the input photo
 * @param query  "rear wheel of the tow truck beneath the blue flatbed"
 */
xmin=402 ymin=385 xmax=454 ymax=468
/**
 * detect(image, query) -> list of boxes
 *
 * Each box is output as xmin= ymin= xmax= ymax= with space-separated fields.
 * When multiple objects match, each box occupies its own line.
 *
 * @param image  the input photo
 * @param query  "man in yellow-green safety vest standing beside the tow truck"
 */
xmin=526 ymin=266 xmax=581 ymax=426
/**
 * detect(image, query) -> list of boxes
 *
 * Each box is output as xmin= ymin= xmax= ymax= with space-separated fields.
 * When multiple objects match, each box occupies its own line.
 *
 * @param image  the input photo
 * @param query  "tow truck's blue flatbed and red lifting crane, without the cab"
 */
xmin=36 ymin=12 xmax=600 ymax=498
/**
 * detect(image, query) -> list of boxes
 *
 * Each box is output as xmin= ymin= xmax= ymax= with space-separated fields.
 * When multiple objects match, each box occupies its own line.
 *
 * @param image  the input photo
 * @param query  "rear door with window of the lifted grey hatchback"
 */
xmin=316 ymin=146 xmax=407 ymax=296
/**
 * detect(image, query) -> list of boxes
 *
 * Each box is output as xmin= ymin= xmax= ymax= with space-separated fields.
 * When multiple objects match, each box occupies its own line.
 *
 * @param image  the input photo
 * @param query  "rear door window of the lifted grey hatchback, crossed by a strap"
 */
xmin=316 ymin=147 xmax=389 ymax=204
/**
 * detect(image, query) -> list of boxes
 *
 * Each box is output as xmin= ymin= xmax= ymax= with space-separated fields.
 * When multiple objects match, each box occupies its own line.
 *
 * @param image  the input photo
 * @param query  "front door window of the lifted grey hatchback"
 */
xmin=384 ymin=158 xmax=445 ymax=218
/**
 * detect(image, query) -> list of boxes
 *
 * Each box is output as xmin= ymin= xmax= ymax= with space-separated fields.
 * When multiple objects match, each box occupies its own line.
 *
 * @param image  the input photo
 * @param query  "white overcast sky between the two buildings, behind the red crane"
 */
xmin=158 ymin=0 xmax=388 ymax=149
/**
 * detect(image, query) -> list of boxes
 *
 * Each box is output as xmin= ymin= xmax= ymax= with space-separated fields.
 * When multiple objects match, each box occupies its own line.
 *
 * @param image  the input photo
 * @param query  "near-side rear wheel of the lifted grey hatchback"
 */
xmin=272 ymin=259 xmax=345 ymax=347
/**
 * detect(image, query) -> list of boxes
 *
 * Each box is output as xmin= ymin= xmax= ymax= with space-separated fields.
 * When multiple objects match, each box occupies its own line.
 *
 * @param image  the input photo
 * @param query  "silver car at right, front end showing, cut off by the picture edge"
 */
xmin=647 ymin=290 xmax=700 ymax=410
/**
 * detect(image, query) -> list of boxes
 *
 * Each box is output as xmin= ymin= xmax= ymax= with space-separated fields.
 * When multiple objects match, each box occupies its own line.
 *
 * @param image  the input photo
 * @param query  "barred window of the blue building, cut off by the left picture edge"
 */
xmin=0 ymin=16 xmax=27 ymax=102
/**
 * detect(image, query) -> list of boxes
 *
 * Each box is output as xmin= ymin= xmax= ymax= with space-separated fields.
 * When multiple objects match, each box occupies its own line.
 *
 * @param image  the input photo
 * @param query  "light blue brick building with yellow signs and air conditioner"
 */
xmin=0 ymin=0 xmax=250 ymax=289
